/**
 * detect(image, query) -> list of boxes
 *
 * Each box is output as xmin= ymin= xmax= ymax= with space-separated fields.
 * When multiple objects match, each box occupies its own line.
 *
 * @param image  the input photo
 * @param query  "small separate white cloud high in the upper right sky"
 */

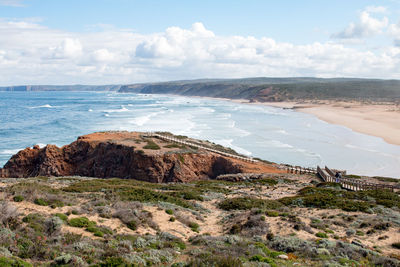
xmin=332 ymin=6 xmax=389 ymax=39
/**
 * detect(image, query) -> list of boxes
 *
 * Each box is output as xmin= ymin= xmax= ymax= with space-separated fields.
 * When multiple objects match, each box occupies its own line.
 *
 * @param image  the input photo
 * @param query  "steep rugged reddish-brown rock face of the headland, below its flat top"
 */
xmin=0 ymin=135 xmax=243 ymax=182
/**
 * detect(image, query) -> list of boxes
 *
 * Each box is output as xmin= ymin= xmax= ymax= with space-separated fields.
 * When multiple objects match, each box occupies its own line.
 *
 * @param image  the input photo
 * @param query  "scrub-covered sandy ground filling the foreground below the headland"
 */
xmin=0 ymin=175 xmax=400 ymax=267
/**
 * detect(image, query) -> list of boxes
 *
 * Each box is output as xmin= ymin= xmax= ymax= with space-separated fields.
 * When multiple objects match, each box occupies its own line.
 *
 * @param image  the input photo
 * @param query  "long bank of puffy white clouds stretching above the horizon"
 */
xmin=0 ymin=20 xmax=400 ymax=85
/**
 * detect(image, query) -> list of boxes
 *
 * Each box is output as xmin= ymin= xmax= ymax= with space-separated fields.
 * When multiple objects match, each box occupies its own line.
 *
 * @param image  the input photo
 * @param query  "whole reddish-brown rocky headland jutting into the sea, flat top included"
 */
xmin=0 ymin=132 xmax=280 ymax=182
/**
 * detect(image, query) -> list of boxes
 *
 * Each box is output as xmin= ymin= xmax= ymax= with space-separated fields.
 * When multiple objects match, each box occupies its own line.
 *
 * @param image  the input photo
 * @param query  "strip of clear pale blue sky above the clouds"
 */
xmin=0 ymin=0 xmax=400 ymax=44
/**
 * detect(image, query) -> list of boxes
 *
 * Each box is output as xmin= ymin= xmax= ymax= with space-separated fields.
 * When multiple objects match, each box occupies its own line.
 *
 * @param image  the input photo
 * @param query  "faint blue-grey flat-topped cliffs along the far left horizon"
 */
xmin=0 ymin=84 xmax=121 ymax=91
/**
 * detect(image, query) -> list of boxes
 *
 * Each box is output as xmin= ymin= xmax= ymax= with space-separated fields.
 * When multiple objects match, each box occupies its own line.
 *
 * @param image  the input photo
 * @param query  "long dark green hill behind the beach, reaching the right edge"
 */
xmin=119 ymin=77 xmax=400 ymax=102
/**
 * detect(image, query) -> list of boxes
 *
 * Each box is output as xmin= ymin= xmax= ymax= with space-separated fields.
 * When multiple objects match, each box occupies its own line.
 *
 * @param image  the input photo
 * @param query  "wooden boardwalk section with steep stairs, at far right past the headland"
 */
xmin=317 ymin=166 xmax=395 ymax=191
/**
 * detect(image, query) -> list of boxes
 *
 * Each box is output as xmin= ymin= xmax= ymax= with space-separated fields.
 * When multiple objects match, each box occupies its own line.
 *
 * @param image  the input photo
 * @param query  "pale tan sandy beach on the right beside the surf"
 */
xmin=260 ymin=101 xmax=400 ymax=145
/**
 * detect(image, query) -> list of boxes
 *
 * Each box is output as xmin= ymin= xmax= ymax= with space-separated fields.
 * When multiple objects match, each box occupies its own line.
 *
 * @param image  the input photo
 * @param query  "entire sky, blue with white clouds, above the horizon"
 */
xmin=0 ymin=0 xmax=400 ymax=86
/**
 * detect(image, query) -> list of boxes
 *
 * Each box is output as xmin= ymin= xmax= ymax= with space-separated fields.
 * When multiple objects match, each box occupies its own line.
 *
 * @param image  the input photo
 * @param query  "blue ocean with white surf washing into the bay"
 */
xmin=0 ymin=92 xmax=400 ymax=178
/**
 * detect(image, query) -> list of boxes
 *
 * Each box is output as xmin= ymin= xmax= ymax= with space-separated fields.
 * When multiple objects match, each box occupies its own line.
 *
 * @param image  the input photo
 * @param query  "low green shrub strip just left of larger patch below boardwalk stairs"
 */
xmin=218 ymin=197 xmax=282 ymax=210
